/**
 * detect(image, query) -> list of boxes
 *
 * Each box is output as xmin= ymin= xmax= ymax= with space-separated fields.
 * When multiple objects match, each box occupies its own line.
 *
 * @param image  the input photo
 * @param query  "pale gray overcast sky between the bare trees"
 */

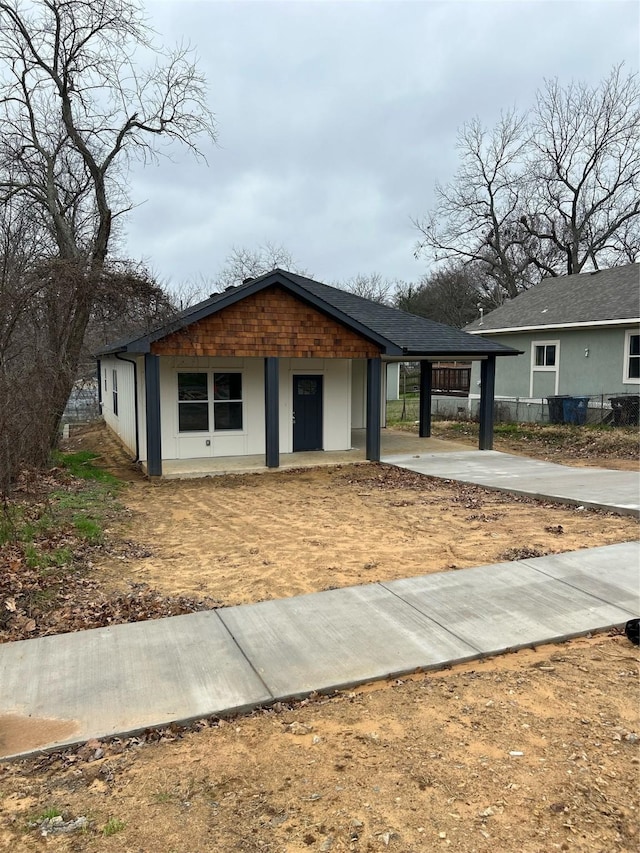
xmin=126 ymin=0 xmax=640 ymax=286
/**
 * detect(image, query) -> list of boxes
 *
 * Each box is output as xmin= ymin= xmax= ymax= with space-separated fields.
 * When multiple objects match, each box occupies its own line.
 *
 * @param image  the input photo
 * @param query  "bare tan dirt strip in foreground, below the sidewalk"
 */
xmin=0 ymin=636 xmax=640 ymax=853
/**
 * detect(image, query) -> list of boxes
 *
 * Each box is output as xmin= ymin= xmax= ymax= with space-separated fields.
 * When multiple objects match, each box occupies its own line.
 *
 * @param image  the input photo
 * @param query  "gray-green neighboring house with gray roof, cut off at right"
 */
xmin=465 ymin=263 xmax=640 ymax=420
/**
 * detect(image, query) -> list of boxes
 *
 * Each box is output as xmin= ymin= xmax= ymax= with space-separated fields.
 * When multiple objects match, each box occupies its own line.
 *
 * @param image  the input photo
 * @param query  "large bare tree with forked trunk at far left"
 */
xmin=0 ymin=0 xmax=214 ymax=452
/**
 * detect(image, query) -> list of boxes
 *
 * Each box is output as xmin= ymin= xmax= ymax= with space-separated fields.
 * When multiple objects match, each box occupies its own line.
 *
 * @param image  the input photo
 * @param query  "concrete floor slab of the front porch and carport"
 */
xmin=155 ymin=429 xmax=475 ymax=480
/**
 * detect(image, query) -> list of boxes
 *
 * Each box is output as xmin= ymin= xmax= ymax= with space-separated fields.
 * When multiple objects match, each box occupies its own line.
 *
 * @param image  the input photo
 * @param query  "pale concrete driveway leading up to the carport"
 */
xmin=382 ymin=450 xmax=640 ymax=516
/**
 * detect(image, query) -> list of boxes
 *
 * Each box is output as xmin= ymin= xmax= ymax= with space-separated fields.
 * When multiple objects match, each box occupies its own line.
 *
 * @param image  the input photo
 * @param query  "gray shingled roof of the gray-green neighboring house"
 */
xmin=465 ymin=264 xmax=640 ymax=335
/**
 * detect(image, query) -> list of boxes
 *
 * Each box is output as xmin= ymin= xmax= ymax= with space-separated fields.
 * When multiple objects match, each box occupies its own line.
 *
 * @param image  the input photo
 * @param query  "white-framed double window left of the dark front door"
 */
xmin=178 ymin=371 xmax=243 ymax=432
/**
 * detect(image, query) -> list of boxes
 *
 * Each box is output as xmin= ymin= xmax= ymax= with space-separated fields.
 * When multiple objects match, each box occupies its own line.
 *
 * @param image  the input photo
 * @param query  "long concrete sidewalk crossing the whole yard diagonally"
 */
xmin=0 ymin=543 xmax=640 ymax=757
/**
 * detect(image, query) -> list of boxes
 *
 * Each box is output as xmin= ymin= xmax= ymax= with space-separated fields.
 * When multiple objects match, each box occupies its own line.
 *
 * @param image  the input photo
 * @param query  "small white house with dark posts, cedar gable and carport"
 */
xmin=98 ymin=269 xmax=517 ymax=476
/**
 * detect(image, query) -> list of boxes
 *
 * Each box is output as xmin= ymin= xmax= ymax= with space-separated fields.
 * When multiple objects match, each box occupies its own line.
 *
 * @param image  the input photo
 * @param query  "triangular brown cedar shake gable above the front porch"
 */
xmin=151 ymin=285 xmax=381 ymax=358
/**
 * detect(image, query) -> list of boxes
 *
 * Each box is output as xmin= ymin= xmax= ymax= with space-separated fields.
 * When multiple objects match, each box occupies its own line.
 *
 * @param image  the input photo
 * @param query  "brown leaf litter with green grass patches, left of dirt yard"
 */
xmin=0 ymin=462 xmax=217 ymax=642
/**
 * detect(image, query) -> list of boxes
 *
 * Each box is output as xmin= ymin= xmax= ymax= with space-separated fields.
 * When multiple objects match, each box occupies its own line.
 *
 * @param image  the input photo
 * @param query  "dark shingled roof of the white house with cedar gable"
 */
xmin=98 ymin=269 xmax=518 ymax=358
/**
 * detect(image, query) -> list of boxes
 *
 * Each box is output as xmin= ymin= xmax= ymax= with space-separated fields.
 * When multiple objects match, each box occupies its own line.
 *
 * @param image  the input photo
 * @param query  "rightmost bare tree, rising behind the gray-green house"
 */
xmin=521 ymin=66 xmax=640 ymax=275
